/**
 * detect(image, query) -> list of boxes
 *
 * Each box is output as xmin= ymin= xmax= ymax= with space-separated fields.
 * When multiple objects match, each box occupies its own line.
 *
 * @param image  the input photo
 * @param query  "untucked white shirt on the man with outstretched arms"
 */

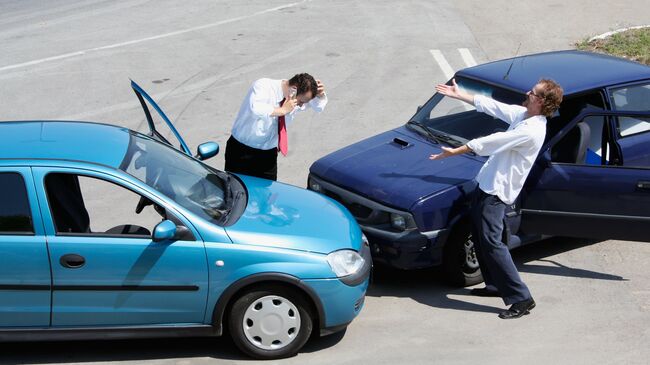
xmin=467 ymin=95 xmax=546 ymax=204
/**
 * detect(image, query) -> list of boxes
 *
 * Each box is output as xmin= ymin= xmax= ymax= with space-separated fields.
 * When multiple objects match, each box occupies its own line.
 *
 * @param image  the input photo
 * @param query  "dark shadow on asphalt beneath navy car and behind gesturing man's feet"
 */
xmin=368 ymin=237 xmax=627 ymax=313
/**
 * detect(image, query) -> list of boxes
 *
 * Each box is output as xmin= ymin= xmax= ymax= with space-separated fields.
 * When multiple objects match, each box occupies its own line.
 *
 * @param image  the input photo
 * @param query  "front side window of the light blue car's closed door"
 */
xmin=45 ymin=173 xmax=172 ymax=237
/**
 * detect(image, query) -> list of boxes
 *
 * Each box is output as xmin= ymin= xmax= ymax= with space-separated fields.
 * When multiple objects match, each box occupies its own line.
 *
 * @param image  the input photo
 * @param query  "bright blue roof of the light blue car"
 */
xmin=0 ymin=121 xmax=131 ymax=168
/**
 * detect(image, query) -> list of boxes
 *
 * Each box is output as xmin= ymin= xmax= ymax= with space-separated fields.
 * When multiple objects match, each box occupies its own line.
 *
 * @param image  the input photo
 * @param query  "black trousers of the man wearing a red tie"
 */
xmin=224 ymin=136 xmax=278 ymax=181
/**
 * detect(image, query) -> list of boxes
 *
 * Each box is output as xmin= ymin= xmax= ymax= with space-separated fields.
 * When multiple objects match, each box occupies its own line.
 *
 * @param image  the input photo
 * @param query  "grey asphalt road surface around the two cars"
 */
xmin=0 ymin=0 xmax=650 ymax=364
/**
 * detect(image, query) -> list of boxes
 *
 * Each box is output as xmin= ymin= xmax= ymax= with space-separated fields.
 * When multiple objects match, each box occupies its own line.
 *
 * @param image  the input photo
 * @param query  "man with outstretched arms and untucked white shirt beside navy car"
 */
xmin=429 ymin=79 xmax=563 ymax=319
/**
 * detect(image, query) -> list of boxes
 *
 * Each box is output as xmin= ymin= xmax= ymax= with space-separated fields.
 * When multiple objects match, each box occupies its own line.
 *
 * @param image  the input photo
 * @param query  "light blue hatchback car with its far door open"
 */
xmin=0 ymin=82 xmax=372 ymax=359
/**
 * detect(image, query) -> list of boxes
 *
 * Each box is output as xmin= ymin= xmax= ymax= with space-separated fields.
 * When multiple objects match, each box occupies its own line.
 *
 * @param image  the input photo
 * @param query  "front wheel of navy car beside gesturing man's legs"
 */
xmin=442 ymin=229 xmax=483 ymax=287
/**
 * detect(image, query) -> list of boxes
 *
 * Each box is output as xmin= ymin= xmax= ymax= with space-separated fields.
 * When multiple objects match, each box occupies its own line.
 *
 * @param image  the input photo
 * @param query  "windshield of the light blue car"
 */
xmin=120 ymin=133 xmax=231 ymax=224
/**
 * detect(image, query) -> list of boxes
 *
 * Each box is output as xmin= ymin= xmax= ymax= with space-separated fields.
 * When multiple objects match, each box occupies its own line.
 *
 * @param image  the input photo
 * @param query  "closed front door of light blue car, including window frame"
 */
xmin=34 ymin=168 xmax=208 ymax=327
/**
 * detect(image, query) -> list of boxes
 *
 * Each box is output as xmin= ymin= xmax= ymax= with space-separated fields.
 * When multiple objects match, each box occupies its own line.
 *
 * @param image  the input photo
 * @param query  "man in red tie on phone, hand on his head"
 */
xmin=225 ymin=73 xmax=327 ymax=180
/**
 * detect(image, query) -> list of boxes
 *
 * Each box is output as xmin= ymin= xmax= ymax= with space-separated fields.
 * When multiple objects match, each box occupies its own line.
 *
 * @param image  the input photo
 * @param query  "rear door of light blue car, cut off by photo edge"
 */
xmin=0 ymin=166 xmax=51 ymax=328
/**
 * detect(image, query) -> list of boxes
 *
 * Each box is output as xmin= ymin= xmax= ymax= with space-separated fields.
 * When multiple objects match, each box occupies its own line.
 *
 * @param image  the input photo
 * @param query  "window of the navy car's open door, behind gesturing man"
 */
xmin=551 ymin=116 xmax=611 ymax=165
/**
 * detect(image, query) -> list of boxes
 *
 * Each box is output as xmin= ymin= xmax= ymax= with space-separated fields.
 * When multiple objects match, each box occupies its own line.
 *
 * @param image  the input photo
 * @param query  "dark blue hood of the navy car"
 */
xmin=310 ymin=127 xmax=484 ymax=210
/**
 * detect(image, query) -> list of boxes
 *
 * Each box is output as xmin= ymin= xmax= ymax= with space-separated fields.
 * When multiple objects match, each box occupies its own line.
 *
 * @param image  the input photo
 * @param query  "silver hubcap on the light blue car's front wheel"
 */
xmin=242 ymin=295 xmax=300 ymax=350
